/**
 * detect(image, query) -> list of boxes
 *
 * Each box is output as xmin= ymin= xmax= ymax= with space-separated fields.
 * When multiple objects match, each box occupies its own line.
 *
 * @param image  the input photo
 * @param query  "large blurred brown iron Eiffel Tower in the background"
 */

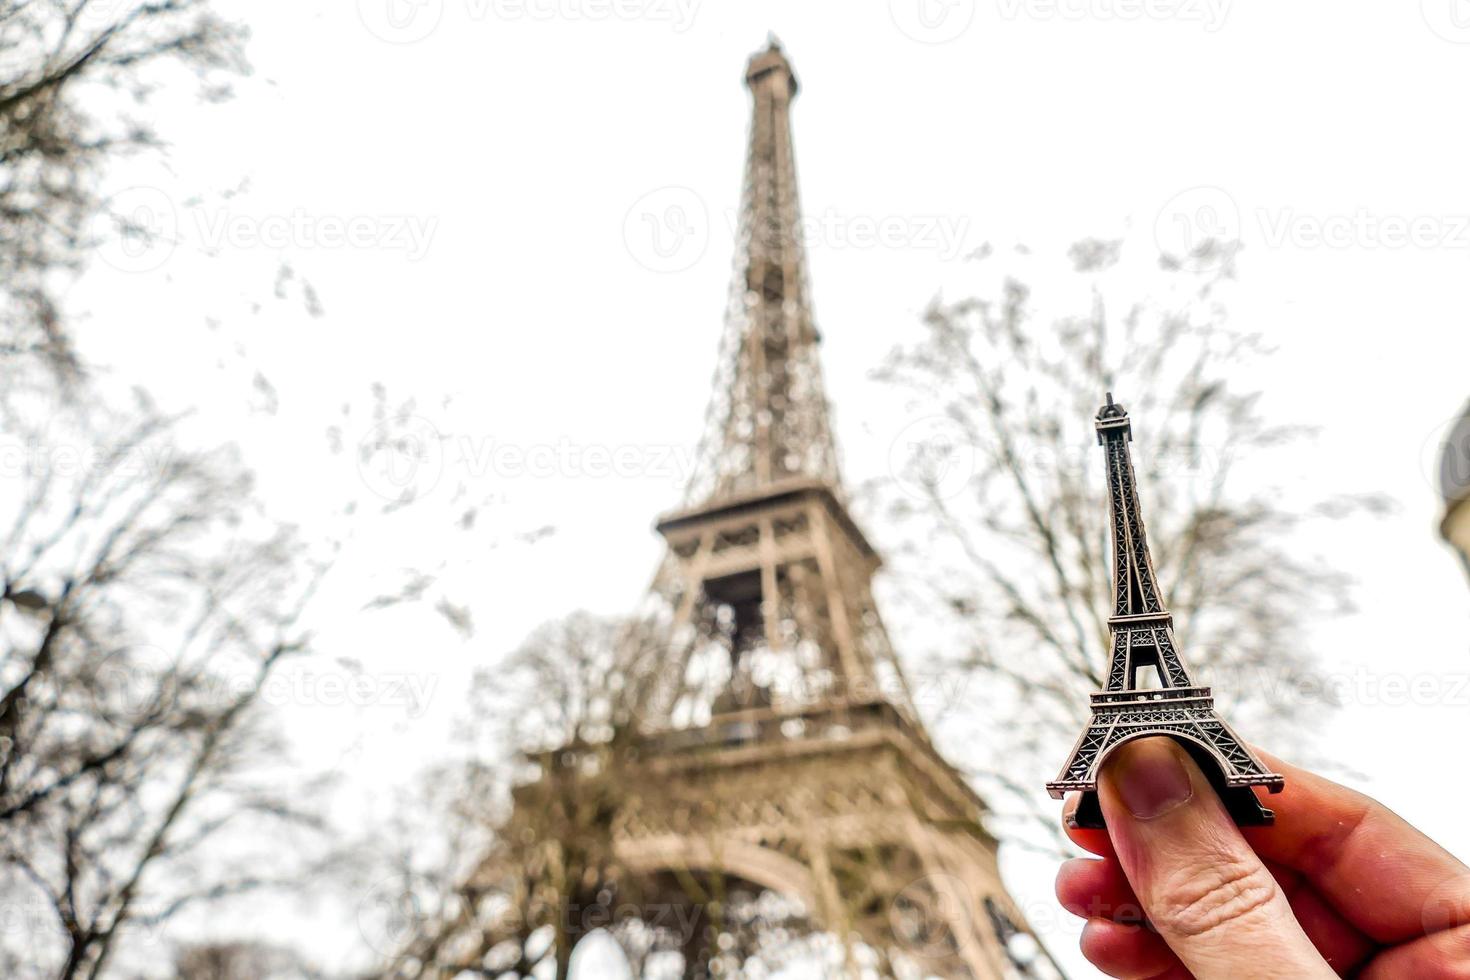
xmin=429 ymin=38 xmax=1060 ymax=977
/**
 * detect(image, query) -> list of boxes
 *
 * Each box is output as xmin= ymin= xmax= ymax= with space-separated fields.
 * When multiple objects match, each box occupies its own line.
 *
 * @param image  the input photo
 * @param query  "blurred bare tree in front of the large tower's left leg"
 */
xmin=367 ymin=614 xmax=649 ymax=977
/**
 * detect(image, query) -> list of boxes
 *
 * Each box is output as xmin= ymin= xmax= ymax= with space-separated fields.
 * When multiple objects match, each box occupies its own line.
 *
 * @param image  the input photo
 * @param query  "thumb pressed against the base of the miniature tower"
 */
xmin=1098 ymin=738 xmax=1336 ymax=980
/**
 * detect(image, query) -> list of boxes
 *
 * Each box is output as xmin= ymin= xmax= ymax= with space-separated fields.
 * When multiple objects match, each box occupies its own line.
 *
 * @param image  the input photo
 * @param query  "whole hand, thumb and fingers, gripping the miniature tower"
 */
xmin=1057 ymin=738 xmax=1470 ymax=980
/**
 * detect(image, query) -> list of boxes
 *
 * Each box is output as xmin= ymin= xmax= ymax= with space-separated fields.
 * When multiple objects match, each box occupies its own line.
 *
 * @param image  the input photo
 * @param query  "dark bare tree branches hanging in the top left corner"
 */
xmin=0 ymin=0 xmax=245 ymax=373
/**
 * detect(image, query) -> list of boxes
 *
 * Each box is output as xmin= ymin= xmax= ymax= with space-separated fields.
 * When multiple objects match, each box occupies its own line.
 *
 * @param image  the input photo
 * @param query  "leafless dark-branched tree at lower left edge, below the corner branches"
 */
xmin=0 ymin=376 xmax=333 ymax=977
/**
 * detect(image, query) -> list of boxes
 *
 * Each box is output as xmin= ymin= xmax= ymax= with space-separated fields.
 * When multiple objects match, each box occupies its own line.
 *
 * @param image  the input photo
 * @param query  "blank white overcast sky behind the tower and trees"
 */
xmin=75 ymin=0 xmax=1470 ymax=976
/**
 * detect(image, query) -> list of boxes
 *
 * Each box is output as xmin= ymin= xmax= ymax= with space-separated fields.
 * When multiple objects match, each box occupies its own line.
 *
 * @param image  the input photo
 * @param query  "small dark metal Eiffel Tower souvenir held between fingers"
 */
xmin=1047 ymin=394 xmax=1285 ymax=827
